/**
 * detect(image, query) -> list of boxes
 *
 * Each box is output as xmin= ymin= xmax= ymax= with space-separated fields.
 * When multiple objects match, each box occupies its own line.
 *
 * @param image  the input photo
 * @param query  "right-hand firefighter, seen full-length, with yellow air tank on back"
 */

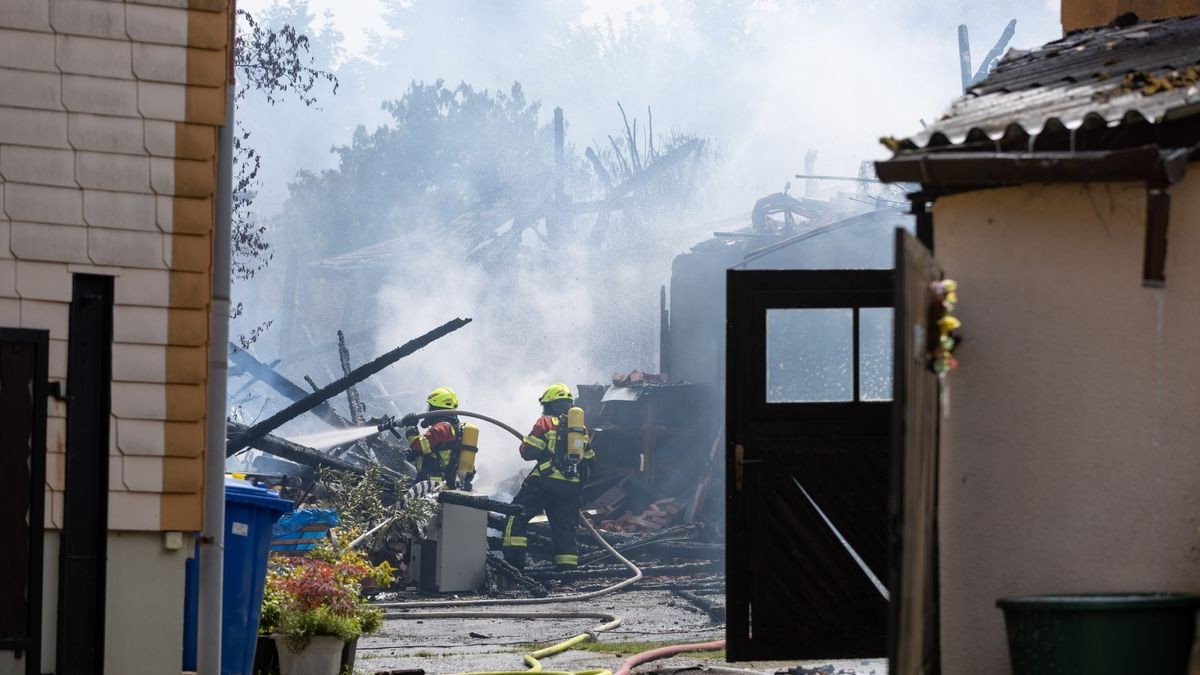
xmin=504 ymin=384 xmax=595 ymax=569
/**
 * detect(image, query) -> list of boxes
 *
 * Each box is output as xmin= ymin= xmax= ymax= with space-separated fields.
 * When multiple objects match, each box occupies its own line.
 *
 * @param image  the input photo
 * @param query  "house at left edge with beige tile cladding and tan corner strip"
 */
xmin=0 ymin=0 xmax=230 ymax=675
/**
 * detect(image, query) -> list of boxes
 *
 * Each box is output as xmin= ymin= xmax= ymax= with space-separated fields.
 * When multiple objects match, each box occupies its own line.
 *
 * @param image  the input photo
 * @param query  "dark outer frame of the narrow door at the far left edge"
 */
xmin=0 ymin=328 xmax=49 ymax=675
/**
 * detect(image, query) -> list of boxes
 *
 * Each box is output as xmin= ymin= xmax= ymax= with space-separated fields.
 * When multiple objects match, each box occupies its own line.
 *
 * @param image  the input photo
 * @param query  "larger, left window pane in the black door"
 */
xmin=767 ymin=309 xmax=854 ymax=404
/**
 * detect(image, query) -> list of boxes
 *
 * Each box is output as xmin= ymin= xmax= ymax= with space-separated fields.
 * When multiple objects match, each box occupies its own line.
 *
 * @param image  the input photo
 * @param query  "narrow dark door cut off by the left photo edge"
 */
xmin=0 ymin=328 xmax=49 ymax=675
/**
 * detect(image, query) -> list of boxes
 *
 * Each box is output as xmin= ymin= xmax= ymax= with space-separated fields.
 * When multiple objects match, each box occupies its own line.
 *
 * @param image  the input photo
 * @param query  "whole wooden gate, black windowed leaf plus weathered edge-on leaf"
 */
xmin=726 ymin=229 xmax=941 ymax=662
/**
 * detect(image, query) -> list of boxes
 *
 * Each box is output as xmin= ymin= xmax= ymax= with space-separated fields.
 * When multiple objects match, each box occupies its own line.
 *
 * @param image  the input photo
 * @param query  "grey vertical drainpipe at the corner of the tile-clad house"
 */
xmin=197 ymin=0 xmax=238 ymax=675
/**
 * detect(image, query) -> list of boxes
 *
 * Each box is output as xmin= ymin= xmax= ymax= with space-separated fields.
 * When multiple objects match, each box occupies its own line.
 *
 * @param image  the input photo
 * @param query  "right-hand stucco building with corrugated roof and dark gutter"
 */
xmin=877 ymin=0 xmax=1200 ymax=675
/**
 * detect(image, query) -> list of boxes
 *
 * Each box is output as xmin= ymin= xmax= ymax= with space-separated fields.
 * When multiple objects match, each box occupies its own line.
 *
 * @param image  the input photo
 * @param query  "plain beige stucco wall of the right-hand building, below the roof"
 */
xmin=934 ymin=171 xmax=1200 ymax=675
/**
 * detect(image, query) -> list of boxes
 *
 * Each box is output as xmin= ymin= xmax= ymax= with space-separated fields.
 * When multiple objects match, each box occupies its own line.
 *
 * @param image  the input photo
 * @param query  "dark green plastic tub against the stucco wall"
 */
xmin=996 ymin=593 xmax=1200 ymax=675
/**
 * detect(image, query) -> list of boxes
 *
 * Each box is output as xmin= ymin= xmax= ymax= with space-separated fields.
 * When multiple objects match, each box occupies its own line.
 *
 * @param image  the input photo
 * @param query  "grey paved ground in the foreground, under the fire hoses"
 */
xmin=355 ymin=591 xmax=887 ymax=675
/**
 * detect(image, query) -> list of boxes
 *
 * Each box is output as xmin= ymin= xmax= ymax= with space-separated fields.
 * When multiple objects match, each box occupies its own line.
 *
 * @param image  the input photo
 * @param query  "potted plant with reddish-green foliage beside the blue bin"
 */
xmin=260 ymin=544 xmax=392 ymax=675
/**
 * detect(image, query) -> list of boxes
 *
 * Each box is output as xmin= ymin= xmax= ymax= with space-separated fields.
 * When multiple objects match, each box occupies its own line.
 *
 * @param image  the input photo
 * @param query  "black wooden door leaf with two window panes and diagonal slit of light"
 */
xmin=726 ymin=264 xmax=895 ymax=661
